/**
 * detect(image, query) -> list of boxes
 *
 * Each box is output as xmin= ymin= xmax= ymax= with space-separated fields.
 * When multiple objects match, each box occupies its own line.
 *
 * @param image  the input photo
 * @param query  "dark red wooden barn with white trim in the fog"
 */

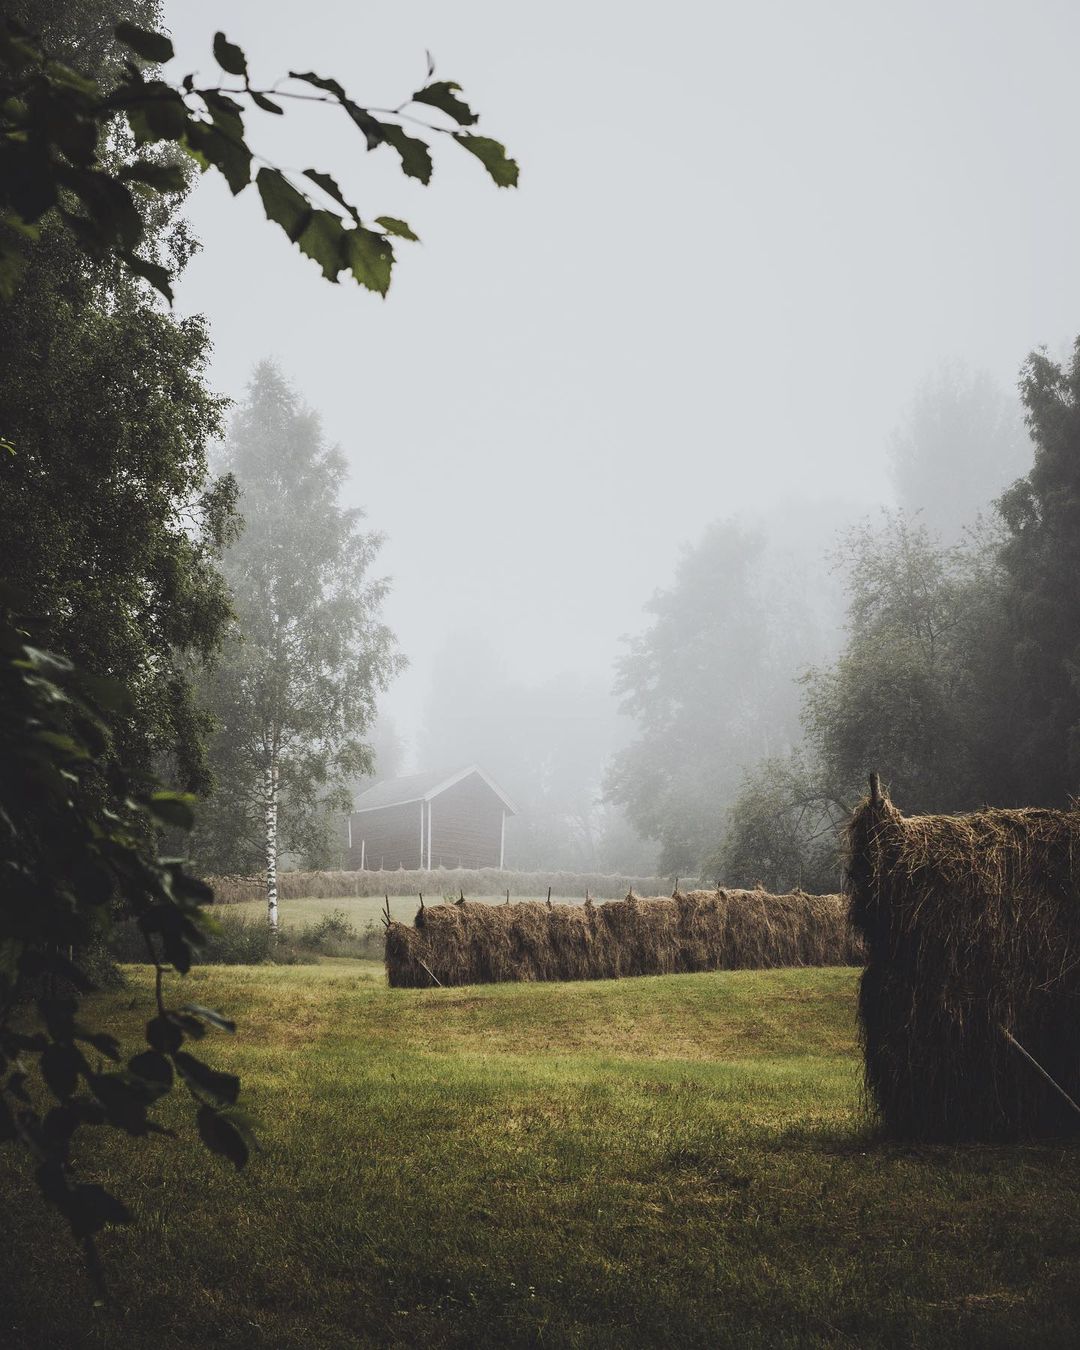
xmin=348 ymin=764 xmax=517 ymax=871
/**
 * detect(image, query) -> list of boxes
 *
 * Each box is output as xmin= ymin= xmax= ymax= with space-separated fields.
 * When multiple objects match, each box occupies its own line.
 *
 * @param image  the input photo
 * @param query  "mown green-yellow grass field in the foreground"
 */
xmin=0 ymin=966 xmax=1080 ymax=1350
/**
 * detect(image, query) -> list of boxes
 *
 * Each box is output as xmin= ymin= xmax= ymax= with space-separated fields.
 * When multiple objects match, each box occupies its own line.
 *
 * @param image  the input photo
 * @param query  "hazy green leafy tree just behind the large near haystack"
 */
xmin=711 ymin=513 xmax=1015 ymax=888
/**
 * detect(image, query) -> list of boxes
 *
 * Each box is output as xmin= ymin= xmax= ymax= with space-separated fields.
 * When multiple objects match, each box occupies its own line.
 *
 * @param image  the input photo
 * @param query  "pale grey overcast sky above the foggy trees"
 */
xmin=169 ymin=0 xmax=1080 ymax=766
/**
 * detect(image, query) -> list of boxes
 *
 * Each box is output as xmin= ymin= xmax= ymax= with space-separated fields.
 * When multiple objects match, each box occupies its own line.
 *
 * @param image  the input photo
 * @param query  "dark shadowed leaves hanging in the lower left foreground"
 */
xmin=0 ymin=605 xmax=251 ymax=1280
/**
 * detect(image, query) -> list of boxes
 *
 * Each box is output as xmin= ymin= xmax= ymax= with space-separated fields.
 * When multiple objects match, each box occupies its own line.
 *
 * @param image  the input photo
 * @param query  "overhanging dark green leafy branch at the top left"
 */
xmin=0 ymin=19 xmax=518 ymax=298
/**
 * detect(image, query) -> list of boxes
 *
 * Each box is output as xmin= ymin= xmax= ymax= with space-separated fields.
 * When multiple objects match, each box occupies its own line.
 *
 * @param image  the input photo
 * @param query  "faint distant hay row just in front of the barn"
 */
xmin=207 ymin=867 xmax=671 ymax=905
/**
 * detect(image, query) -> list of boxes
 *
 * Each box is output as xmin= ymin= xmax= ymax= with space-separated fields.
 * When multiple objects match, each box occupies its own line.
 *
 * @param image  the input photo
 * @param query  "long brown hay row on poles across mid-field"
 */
xmin=386 ymin=890 xmax=860 ymax=988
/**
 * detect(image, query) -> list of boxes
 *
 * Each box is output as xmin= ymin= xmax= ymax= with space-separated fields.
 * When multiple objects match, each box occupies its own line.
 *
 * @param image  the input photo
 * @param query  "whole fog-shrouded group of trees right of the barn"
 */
xmin=608 ymin=342 xmax=1080 ymax=890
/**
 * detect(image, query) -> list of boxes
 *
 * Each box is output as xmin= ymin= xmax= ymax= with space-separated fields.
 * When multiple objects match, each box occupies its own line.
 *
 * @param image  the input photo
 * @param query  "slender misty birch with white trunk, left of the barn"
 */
xmin=197 ymin=362 xmax=402 ymax=930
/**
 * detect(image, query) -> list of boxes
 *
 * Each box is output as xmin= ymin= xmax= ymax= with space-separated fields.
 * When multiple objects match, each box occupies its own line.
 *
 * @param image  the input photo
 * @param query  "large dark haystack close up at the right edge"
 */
xmin=849 ymin=797 xmax=1080 ymax=1141
